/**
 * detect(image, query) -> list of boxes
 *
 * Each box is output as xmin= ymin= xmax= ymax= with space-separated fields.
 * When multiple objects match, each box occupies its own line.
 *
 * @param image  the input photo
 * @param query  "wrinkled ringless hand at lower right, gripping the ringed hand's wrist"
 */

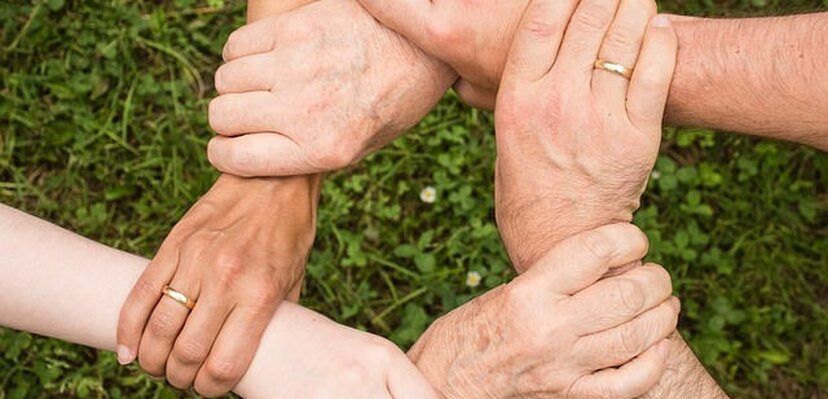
xmin=409 ymin=224 xmax=679 ymax=399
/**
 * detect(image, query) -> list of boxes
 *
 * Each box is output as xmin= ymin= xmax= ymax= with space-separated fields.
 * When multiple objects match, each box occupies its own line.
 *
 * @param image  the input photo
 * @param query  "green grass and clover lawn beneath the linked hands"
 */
xmin=0 ymin=0 xmax=828 ymax=398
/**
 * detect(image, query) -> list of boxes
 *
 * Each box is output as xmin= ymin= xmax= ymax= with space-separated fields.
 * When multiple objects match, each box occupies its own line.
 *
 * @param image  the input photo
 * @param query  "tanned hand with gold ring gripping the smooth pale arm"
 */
xmin=118 ymin=175 xmax=320 ymax=396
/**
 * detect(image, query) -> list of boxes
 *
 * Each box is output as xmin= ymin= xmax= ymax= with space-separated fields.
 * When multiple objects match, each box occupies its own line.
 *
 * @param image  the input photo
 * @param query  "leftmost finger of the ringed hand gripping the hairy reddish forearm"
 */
xmin=503 ymin=0 xmax=580 ymax=84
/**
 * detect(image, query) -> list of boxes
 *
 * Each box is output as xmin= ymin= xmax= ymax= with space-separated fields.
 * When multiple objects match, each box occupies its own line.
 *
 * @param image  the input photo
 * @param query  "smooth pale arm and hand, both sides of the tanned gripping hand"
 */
xmin=0 ymin=204 xmax=433 ymax=399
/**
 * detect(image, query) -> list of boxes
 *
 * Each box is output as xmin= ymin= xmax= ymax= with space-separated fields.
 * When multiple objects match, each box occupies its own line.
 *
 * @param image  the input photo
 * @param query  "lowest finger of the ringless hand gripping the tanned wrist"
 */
xmin=207 ymin=133 xmax=308 ymax=177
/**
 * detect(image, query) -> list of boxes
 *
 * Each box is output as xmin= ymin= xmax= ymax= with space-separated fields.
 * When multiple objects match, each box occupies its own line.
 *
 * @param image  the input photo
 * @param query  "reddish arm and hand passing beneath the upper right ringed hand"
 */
xmin=360 ymin=0 xmax=828 ymax=150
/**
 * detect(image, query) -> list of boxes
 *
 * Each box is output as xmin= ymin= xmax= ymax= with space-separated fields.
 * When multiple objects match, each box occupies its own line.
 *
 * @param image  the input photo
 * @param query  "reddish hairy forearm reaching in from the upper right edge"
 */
xmin=666 ymin=13 xmax=828 ymax=150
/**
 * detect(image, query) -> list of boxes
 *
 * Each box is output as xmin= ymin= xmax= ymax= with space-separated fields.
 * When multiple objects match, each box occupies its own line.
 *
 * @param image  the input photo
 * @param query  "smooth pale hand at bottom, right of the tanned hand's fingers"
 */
xmin=236 ymin=303 xmax=437 ymax=399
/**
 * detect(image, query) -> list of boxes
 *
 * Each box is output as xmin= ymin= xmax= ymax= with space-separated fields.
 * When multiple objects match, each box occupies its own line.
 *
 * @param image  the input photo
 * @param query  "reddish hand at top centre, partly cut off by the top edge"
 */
xmin=359 ymin=0 xmax=532 ymax=109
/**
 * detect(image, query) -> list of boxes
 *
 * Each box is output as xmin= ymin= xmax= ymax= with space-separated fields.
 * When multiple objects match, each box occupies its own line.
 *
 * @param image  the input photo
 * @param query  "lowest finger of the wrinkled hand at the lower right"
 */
xmin=571 ymin=339 xmax=672 ymax=399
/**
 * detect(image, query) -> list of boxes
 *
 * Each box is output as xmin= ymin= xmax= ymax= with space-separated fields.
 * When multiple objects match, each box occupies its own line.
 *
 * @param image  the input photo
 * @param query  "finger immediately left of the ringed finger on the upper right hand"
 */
xmin=558 ymin=0 xmax=619 ymax=77
